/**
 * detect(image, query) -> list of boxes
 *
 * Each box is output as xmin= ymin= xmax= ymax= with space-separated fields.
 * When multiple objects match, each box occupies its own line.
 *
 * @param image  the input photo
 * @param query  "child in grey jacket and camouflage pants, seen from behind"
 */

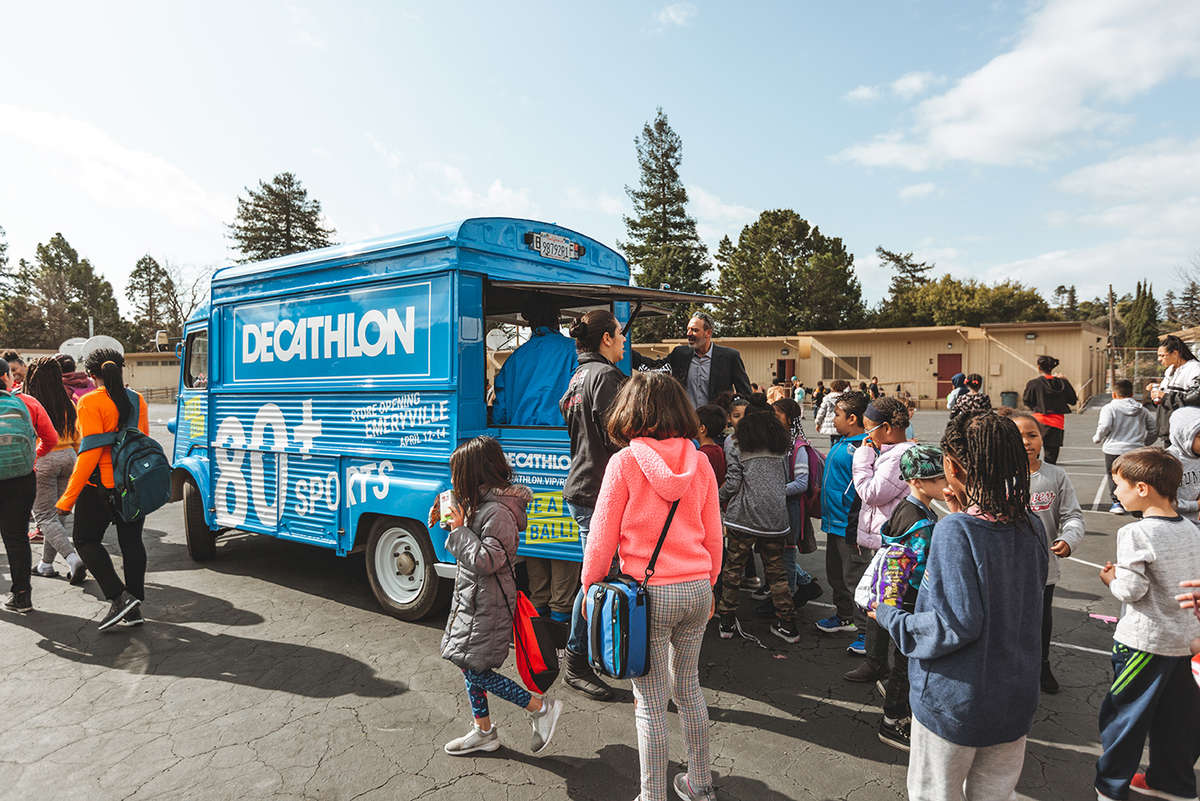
xmin=716 ymin=405 xmax=800 ymax=643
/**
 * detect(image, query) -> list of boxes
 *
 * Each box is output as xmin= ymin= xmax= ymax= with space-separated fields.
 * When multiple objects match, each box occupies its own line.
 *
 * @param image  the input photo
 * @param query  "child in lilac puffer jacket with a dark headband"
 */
xmin=842 ymin=397 xmax=913 ymax=682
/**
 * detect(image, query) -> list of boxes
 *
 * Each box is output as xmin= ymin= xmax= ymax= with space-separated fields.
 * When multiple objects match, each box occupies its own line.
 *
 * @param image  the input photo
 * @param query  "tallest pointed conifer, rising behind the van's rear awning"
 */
xmin=618 ymin=108 xmax=712 ymax=342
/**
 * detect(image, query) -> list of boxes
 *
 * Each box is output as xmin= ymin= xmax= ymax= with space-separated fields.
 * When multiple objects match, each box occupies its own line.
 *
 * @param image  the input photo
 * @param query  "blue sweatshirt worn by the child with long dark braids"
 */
xmin=875 ymin=512 xmax=1049 ymax=748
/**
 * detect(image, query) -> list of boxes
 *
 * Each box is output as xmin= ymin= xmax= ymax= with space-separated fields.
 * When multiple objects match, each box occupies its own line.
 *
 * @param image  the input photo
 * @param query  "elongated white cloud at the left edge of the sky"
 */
xmin=0 ymin=103 xmax=234 ymax=229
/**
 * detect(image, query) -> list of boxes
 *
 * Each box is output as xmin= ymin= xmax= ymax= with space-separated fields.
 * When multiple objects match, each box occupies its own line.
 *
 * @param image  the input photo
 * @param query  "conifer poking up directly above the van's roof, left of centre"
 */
xmin=228 ymin=173 xmax=335 ymax=261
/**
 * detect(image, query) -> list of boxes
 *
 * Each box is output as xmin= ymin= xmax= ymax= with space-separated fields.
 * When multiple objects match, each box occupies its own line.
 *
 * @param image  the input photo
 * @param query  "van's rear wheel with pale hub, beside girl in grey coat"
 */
xmin=366 ymin=519 xmax=449 ymax=620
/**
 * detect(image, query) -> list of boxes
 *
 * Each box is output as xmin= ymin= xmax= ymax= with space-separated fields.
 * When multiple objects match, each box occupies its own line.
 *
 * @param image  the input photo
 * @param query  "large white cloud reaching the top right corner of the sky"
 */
xmin=841 ymin=0 xmax=1200 ymax=170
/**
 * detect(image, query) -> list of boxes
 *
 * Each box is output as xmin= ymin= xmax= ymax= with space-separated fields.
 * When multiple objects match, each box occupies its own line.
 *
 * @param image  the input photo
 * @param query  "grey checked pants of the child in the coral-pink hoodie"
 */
xmin=632 ymin=579 xmax=713 ymax=801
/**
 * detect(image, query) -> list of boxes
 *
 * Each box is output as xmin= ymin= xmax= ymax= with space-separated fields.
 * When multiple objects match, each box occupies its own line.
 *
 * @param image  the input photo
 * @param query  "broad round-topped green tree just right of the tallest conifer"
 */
xmin=716 ymin=209 xmax=864 ymax=337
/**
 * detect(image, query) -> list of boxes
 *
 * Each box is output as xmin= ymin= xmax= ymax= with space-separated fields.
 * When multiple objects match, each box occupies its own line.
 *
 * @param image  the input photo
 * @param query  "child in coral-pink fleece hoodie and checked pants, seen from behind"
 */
xmin=582 ymin=373 xmax=721 ymax=801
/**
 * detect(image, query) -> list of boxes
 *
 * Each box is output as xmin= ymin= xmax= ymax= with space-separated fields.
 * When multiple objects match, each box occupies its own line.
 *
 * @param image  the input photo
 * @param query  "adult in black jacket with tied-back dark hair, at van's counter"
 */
xmin=558 ymin=309 xmax=626 ymax=700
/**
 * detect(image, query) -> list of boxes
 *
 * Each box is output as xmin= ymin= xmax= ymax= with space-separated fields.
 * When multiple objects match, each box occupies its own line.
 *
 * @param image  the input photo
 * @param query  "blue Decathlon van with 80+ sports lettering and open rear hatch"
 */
xmin=169 ymin=218 xmax=714 ymax=620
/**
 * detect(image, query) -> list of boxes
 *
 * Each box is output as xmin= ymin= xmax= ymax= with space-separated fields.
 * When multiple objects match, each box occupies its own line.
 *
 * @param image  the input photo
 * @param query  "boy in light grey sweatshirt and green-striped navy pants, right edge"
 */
xmin=1096 ymin=447 xmax=1200 ymax=801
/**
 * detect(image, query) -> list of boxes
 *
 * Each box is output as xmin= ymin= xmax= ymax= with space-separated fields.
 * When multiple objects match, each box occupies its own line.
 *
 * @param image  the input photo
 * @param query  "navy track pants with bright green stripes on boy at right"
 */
xmin=1096 ymin=643 xmax=1200 ymax=799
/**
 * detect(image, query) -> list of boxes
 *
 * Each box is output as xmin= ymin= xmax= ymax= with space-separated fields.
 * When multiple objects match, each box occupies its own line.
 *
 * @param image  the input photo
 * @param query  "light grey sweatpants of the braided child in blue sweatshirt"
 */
xmin=908 ymin=717 xmax=1025 ymax=801
